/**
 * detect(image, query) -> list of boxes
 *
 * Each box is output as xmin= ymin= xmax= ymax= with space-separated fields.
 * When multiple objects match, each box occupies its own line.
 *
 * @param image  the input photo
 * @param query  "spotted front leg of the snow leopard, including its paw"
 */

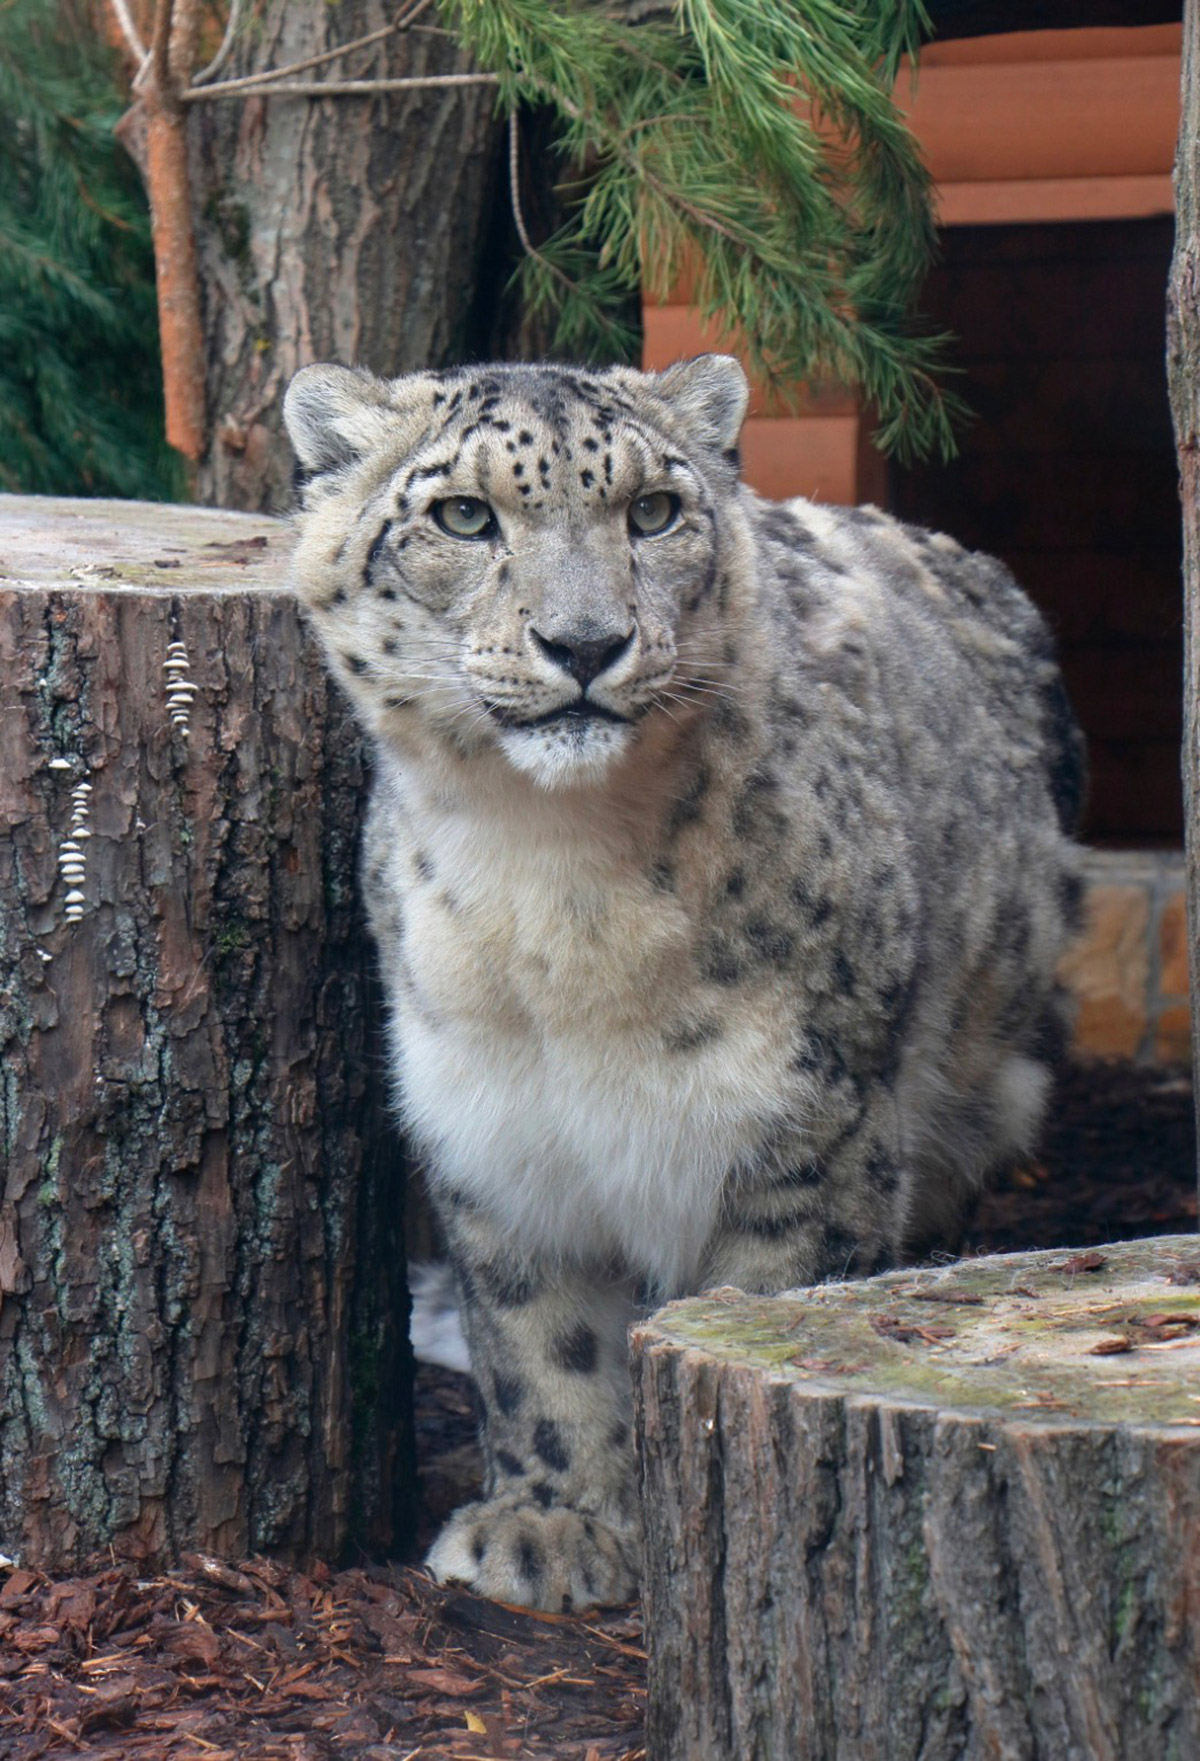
xmin=428 ymin=1212 xmax=641 ymax=1610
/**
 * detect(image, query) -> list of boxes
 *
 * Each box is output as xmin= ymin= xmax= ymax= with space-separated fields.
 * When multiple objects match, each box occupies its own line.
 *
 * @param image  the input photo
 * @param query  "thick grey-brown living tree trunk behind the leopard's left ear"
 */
xmin=189 ymin=0 xmax=507 ymax=509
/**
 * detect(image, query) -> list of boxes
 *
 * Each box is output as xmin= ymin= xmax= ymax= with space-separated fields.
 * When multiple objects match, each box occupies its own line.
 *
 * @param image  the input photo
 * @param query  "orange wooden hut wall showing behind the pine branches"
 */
xmin=643 ymin=25 xmax=1182 ymax=502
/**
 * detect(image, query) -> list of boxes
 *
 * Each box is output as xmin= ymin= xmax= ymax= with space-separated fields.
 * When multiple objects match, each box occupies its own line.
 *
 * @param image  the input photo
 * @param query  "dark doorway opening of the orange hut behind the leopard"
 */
xmin=890 ymin=218 xmax=1182 ymax=845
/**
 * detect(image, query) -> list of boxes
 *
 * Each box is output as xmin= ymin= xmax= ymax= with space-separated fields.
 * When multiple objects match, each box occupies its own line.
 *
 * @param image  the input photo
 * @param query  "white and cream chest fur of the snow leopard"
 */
xmin=378 ymin=750 xmax=786 ymax=1287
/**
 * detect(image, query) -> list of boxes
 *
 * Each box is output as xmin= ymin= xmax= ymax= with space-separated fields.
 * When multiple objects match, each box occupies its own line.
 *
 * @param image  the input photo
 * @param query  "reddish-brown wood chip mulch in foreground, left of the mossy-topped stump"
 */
xmin=0 ymin=1555 xmax=645 ymax=1761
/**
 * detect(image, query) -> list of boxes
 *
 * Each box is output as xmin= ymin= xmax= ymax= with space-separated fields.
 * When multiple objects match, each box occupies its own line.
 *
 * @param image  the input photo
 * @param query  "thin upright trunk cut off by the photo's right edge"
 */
xmin=1167 ymin=0 xmax=1200 ymax=1211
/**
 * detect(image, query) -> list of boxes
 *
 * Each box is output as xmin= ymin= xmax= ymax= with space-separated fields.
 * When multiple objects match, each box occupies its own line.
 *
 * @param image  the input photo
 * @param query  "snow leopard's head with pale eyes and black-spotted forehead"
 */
xmin=284 ymin=356 xmax=747 ymax=785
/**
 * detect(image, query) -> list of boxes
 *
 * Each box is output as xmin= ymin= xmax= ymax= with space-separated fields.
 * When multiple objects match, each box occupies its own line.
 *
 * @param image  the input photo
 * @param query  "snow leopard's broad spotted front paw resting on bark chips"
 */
xmin=425 ymin=1499 xmax=640 ymax=1613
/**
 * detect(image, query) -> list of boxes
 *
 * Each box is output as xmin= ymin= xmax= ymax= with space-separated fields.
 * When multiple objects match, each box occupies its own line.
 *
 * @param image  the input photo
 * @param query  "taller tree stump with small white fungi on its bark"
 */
xmin=0 ymin=497 xmax=412 ymax=1569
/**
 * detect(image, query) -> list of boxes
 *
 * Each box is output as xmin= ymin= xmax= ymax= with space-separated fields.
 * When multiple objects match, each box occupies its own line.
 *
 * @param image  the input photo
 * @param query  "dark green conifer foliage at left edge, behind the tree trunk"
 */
xmin=0 ymin=0 xmax=181 ymax=498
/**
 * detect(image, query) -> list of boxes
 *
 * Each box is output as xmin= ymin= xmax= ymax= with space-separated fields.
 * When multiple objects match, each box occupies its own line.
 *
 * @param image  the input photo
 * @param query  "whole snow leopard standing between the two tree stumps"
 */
xmin=285 ymin=356 xmax=1082 ymax=1610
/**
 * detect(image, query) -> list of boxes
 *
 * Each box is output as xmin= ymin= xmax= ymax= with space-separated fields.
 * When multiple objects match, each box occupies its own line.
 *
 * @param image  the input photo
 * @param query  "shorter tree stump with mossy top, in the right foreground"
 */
xmin=634 ymin=1236 xmax=1200 ymax=1761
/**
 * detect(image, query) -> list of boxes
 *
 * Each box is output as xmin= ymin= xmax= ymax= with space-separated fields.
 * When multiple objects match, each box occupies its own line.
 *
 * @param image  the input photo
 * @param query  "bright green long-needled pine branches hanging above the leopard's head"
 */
xmin=442 ymin=0 xmax=959 ymax=458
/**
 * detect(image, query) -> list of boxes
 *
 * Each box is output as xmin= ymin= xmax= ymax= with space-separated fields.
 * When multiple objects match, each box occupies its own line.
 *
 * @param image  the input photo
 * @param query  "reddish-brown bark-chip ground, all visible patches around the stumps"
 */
xmin=0 ymin=1065 xmax=1196 ymax=1761
